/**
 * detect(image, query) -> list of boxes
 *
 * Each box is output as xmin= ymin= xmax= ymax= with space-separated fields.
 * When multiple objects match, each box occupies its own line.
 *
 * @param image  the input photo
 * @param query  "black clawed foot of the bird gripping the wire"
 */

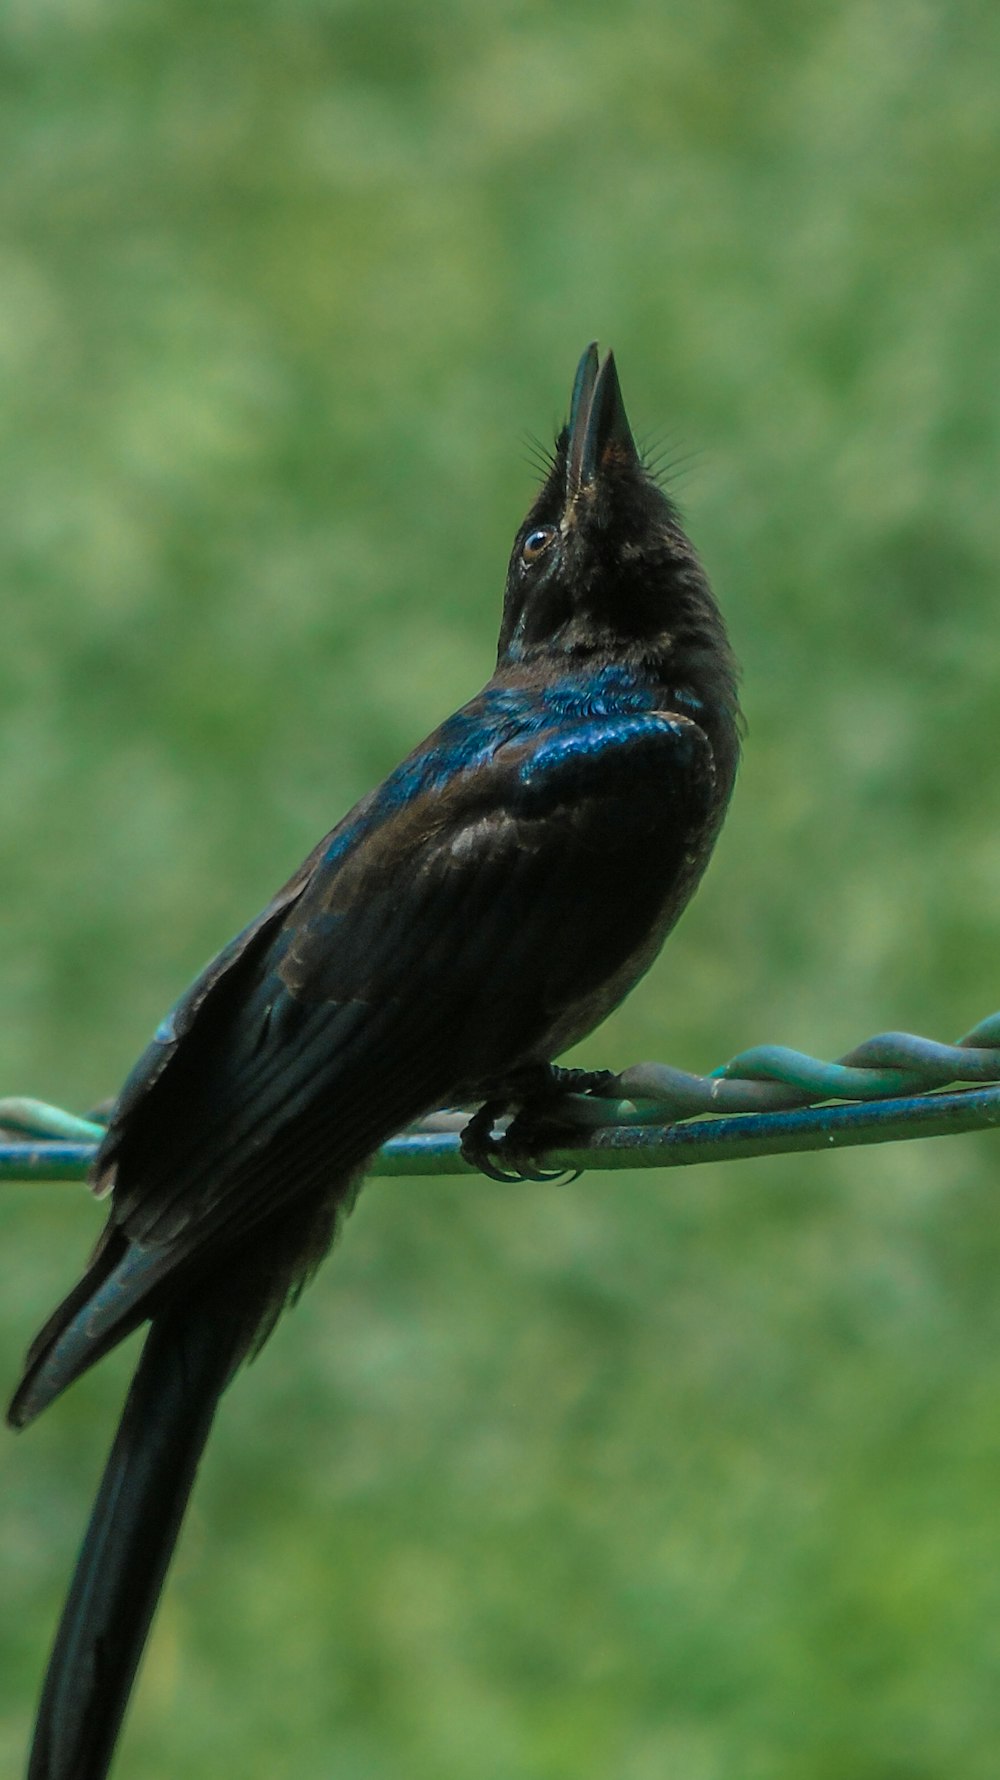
xmin=461 ymin=1063 xmax=616 ymax=1184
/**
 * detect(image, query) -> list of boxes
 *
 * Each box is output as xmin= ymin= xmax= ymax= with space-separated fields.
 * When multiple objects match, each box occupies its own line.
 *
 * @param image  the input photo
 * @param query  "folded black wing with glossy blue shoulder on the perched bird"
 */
xmin=18 ymin=712 xmax=714 ymax=1419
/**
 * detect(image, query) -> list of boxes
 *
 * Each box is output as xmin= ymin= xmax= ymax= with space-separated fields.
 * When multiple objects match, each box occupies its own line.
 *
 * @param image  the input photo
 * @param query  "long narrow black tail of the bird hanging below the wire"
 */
xmin=28 ymin=1296 xmax=247 ymax=1780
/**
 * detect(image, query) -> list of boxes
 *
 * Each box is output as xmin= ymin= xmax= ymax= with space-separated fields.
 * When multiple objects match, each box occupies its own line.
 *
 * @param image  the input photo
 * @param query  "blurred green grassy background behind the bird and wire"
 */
xmin=0 ymin=0 xmax=1000 ymax=1780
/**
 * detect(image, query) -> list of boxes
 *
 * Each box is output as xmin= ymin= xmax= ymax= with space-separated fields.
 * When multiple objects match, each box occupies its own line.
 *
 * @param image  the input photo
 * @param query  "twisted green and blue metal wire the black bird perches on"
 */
xmin=0 ymin=1013 xmax=1000 ymax=1180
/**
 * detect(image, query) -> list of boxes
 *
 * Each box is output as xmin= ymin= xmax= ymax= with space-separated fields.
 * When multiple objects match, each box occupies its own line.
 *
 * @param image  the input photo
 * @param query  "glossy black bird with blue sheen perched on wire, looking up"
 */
xmin=9 ymin=344 xmax=742 ymax=1780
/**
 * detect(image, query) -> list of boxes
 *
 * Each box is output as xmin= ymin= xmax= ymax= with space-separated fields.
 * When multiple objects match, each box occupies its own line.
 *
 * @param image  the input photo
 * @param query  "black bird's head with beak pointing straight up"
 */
xmin=498 ymin=345 xmax=726 ymax=694
